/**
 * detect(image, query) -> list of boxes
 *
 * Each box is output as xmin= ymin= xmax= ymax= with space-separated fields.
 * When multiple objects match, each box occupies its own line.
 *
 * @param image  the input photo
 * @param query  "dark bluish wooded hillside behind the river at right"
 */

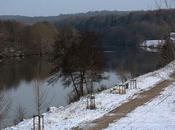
xmin=56 ymin=9 xmax=175 ymax=46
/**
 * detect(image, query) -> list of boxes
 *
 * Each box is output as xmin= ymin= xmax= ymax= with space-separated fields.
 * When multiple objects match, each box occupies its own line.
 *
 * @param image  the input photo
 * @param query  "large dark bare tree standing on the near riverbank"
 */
xmin=54 ymin=28 xmax=105 ymax=97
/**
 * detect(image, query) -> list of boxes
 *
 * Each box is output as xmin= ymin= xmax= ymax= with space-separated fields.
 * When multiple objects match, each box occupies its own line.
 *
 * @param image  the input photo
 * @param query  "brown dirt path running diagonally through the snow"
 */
xmin=76 ymin=74 xmax=175 ymax=130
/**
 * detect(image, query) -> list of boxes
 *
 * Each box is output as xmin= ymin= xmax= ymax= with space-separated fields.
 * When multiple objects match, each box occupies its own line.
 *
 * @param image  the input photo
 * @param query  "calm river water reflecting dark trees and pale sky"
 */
xmin=0 ymin=48 xmax=159 ymax=126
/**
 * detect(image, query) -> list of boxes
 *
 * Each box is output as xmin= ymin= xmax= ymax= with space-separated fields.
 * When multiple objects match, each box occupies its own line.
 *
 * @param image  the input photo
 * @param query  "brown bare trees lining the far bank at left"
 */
xmin=0 ymin=21 xmax=58 ymax=58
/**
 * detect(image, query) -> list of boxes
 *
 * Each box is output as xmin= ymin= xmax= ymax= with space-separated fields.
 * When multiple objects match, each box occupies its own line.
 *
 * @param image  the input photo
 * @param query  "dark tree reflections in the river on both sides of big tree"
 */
xmin=0 ymin=46 xmax=158 ymax=92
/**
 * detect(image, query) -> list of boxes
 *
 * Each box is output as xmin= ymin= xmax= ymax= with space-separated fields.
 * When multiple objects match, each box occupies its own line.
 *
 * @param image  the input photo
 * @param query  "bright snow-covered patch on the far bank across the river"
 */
xmin=140 ymin=40 xmax=165 ymax=48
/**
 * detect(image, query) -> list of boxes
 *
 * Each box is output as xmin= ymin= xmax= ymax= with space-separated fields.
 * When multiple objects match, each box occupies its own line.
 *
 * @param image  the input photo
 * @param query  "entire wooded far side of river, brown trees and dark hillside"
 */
xmin=0 ymin=9 xmax=175 ymax=58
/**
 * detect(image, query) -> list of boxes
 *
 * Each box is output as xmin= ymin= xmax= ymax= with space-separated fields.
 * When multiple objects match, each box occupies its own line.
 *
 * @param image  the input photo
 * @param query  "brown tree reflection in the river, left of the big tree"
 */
xmin=0 ymin=57 xmax=51 ymax=89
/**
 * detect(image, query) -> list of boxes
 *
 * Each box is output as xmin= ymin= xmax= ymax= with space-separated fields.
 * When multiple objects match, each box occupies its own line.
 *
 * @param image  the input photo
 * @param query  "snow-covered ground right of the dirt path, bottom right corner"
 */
xmin=105 ymin=82 xmax=175 ymax=130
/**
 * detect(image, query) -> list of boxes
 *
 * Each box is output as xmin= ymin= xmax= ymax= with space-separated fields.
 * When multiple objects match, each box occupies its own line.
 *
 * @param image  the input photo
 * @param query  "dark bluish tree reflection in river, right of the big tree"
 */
xmin=107 ymin=48 xmax=159 ymax=81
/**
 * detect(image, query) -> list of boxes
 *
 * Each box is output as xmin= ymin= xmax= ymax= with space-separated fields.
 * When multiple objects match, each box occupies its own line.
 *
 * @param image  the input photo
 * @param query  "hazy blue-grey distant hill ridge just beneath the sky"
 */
xmin=0 ymin=10 xmax=129 ymax=24
